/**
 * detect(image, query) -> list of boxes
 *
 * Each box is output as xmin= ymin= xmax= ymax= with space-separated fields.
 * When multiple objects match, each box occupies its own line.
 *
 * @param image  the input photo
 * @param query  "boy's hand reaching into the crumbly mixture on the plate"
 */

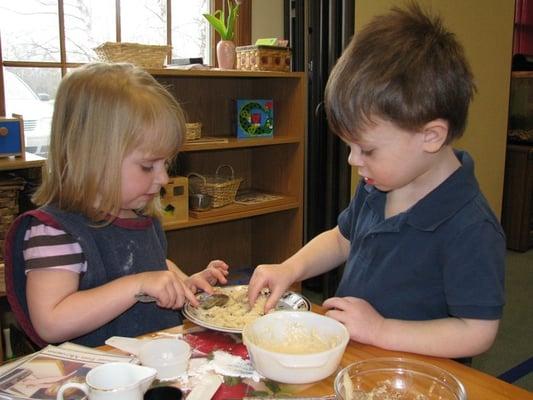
xmin=248 ymin=264 xmax=294 ymax=314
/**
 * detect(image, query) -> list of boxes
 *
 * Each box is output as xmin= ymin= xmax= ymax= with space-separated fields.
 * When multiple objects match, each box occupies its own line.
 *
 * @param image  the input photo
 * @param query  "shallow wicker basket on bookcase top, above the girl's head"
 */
xmin=94 ymin=42 xmax=171 ymax=69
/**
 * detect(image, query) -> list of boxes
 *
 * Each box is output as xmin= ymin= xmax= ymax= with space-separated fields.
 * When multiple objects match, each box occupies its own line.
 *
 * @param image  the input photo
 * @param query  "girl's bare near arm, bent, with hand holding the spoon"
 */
xmin=26 ymin=268 xmax=196 ymax=343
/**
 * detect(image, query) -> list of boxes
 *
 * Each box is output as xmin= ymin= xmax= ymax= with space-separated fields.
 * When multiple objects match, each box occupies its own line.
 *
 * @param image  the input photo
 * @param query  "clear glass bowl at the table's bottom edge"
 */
xmin=335 ymin=358 xmax=466 ymax=400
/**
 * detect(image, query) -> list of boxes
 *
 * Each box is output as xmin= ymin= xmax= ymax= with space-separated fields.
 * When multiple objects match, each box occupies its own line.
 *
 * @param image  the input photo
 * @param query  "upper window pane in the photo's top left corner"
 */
xmin=0 ymin=0 xmax=60 ymax=61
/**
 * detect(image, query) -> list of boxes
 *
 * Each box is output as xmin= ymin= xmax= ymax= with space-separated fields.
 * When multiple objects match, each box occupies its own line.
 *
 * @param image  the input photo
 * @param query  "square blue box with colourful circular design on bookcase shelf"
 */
xmin=237 ymin=99 xmax=274 ymax=139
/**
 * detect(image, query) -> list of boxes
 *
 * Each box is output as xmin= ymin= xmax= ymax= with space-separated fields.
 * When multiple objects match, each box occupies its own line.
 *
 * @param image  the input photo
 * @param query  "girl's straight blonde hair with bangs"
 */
xmin=32 ymin=63 xmax=185 ymax=222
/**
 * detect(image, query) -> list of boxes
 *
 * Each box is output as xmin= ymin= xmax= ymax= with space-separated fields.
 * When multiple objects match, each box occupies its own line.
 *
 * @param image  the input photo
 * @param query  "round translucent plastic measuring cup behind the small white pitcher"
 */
xmin=139 ymin=339 xmax=191 ymax=381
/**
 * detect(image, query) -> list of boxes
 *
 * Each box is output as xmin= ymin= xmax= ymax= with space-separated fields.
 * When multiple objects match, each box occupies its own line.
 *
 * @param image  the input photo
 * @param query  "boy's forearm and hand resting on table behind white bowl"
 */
xmin=324 ymin=297 xmax=499 ymax=358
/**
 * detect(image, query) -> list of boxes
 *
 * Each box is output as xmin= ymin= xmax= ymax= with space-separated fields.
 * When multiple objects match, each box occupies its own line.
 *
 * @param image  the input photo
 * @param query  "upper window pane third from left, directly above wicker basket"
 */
xmin=120 ymin=0 xmax=166 ymax=45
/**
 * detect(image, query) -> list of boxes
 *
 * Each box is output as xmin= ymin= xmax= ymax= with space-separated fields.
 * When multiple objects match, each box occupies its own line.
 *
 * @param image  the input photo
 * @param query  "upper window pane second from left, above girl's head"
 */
xmin=64 ymin=0 xmax=115 ymax=62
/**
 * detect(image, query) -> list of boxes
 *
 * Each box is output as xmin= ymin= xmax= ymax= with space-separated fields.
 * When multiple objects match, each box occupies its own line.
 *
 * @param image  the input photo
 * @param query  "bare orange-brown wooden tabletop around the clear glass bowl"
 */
xmin=102 ymin=305 xmax=533 ymax=400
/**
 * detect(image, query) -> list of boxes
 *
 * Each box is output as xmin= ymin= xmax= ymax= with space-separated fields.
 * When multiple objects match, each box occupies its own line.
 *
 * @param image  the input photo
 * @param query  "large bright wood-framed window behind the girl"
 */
xmin=0 ymin=0 xmax=251 ymax=156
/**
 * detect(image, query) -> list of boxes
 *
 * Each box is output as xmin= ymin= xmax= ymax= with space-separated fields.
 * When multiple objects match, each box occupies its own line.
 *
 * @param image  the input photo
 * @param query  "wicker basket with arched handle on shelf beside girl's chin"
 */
xmin=187 ymin=164 xmax=243 ymax=208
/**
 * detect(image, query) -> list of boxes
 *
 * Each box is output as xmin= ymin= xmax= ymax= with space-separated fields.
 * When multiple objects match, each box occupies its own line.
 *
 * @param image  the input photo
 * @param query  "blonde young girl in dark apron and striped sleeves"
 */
xmin=6 ymin=63 xmax=228 ymax=346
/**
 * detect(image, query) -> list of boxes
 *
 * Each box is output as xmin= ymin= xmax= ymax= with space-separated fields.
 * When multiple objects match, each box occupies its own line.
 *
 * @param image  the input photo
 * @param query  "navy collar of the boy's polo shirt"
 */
xmin=365 ymin=150 xmax=479 ymax=231
